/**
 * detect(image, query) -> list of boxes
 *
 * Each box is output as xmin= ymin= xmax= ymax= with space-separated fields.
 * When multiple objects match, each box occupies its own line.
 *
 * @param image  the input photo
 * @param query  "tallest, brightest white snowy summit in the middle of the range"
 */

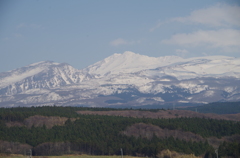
xmin=86 ymin=51 xmax=183 ymax=76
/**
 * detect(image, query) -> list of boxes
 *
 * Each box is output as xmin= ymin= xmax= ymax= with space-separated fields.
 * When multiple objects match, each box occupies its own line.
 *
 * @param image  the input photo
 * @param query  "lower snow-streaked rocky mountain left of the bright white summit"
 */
xmin=0 ymin=61 xmax=91 ymax=95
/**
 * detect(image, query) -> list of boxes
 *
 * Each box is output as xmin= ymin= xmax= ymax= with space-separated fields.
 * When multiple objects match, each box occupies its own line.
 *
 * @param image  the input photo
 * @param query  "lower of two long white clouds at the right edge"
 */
xmin=161 ymin=29 xmax=240 ymax=47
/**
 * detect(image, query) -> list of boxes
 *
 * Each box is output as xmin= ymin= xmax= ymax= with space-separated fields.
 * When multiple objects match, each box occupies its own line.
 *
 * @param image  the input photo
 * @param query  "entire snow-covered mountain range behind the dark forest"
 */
xmin=0 ymin=51 xmax=240 ymax=107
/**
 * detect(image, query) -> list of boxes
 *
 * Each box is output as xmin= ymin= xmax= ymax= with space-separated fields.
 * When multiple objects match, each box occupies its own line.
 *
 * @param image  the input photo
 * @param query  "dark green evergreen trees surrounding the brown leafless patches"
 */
xmin=0 ymin=106 xmax=240 ymax=158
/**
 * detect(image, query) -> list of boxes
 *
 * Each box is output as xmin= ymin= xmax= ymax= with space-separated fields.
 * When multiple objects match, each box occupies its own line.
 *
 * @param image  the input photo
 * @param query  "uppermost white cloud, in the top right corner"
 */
xmin=171 ymin=4 xmax=240 ymax=27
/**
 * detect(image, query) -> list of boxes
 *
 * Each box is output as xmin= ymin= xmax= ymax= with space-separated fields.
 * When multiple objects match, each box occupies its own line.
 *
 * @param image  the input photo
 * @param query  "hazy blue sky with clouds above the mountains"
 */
xmin=0 ymin=0 xmax=240 ymax=72
